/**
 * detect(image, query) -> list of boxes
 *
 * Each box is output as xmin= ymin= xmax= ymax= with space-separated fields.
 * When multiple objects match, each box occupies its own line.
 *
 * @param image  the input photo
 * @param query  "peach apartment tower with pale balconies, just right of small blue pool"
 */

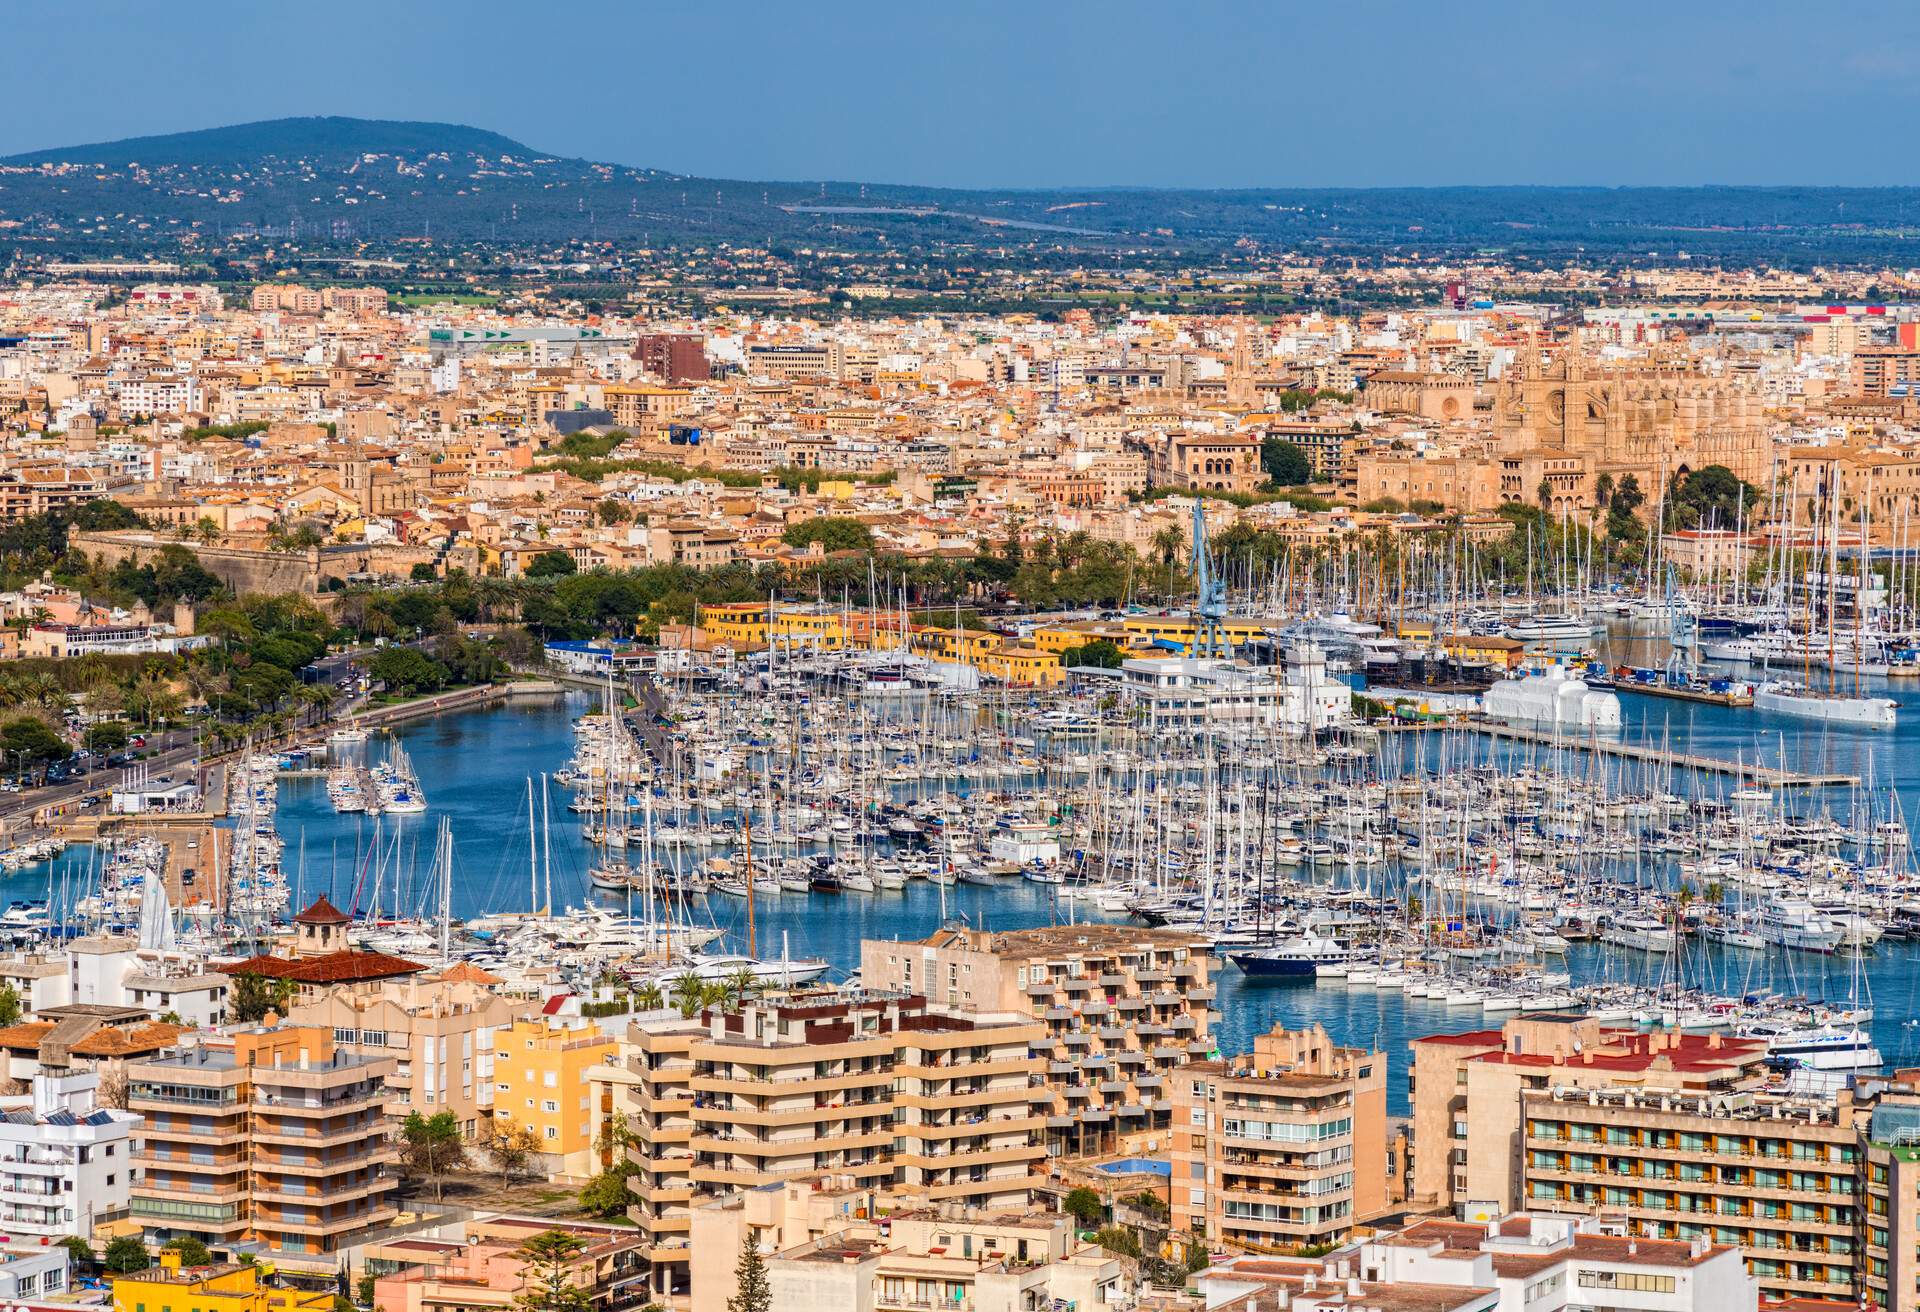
xmin=1167 ymin=1026 xmax=1386 ymax=1247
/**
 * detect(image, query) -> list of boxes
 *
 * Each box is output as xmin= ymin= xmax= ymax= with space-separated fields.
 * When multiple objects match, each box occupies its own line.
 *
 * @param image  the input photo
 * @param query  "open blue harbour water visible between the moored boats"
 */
xmin=0 ymin=668 xmax=1920 ymax=1112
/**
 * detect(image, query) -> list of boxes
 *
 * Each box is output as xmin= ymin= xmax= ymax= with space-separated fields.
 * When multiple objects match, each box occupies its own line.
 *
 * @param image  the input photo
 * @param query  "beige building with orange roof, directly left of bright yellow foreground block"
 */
xmin=286 ymin=962 xmax=534 ymax=1137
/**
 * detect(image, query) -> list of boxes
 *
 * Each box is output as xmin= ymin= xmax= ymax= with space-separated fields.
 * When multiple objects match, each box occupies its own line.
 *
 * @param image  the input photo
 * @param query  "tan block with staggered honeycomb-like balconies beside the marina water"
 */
xmin=860 ymin=924 xmax=1213 ymax=1154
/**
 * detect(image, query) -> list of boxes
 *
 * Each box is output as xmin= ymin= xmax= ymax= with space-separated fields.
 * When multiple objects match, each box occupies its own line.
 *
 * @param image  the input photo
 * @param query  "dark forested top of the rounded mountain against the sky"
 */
xmin=0 ymin=115 xmax=538 ymax=167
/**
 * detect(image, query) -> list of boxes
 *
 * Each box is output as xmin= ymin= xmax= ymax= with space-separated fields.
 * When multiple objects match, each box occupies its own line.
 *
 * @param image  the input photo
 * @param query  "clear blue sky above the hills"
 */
xmin=15 ymin=0 xmax=1920 ymax=186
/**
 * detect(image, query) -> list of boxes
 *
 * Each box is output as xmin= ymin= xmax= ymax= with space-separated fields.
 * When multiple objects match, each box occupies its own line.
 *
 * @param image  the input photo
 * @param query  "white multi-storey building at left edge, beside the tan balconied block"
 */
xmin=0 ymin=1072 xmax=140 ymax=1243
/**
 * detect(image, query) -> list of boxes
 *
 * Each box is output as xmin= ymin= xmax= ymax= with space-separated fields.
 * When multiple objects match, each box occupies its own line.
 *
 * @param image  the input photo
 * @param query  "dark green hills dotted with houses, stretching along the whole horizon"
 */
xmin=0 ymin=117 xmax=1920 ymax=269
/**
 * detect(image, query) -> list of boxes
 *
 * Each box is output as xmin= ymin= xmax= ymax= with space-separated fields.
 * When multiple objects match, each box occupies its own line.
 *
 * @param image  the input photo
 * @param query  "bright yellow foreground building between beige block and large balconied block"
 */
xmin=493 ymin=1018 xmax=618 ymax=1176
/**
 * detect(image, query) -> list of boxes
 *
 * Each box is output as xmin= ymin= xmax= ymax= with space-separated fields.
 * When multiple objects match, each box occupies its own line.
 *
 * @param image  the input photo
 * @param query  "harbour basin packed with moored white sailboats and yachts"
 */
xmin=0 ymin=626 xmax=1920 ymax=1105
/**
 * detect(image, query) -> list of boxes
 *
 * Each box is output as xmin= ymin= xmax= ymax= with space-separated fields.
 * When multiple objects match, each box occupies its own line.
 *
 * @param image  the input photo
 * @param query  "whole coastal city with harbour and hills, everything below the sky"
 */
xmin=11 ymin=15 xmax=1920 ymax=1312
